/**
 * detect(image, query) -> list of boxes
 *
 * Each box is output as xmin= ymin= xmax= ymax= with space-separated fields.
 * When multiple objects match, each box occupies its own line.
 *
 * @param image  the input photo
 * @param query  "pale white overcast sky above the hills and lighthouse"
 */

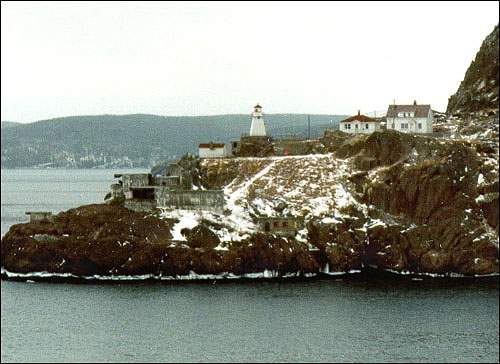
xmin=1 ymin=1 xmax=499 ymax=122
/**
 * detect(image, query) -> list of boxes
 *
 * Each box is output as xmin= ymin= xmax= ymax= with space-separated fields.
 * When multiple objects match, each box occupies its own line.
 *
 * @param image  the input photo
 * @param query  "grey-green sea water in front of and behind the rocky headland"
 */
xmin=1 ymin=170 xmax=499 ymax=362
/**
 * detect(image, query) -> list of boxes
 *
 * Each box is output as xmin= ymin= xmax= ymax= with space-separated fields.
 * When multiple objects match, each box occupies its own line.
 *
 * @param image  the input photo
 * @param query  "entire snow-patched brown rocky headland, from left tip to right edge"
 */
xmin=1 ymin=131 xmax=499 ymax=277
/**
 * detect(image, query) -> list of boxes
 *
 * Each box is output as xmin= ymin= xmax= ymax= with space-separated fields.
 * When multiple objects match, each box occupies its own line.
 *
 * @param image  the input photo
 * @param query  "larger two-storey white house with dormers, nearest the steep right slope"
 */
xmin=386 ymin=101 xmax=434 ymax=133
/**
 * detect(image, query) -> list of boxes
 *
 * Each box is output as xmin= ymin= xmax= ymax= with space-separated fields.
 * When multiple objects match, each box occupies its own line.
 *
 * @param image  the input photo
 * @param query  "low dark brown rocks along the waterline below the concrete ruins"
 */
xmin=1 ymin=204 xmax=318 ymax=277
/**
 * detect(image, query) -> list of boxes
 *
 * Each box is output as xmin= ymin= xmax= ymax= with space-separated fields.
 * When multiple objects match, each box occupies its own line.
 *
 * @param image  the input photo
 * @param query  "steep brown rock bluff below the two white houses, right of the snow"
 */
xmin=330 ymin=133 xmax=498 ymax=274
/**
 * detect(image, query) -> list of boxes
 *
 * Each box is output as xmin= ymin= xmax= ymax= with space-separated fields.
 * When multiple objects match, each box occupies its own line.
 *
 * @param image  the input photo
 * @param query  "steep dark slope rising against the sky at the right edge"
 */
xmin=446 ymin=25 xmax=499 ymax=114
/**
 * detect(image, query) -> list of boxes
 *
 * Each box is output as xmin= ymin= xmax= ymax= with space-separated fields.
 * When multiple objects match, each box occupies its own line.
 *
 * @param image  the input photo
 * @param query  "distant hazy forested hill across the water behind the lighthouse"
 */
xmin=1 ymin=114 xmax=345 ymax=168
